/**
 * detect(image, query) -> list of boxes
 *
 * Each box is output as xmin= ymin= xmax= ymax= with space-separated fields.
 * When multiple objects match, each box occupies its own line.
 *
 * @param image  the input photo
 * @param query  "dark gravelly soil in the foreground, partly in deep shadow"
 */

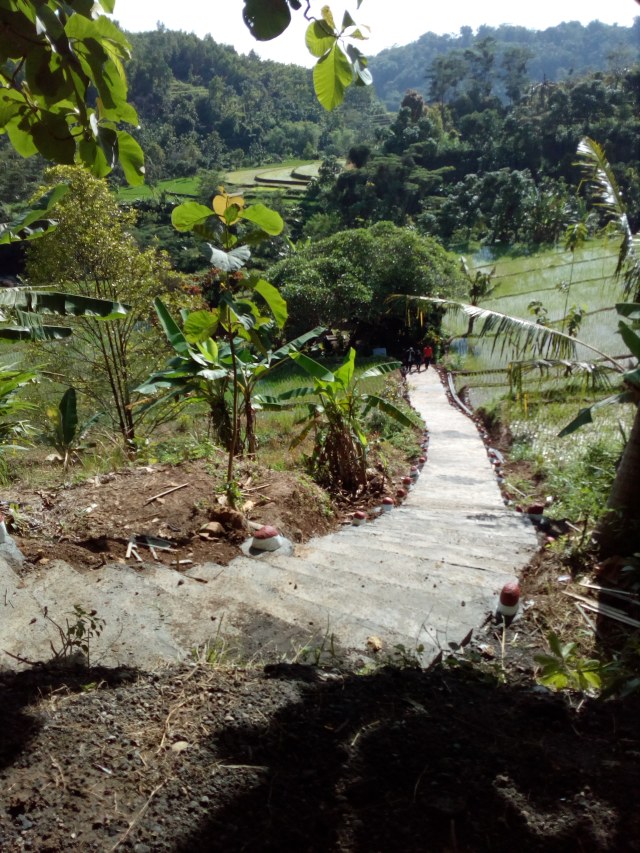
xmin=0 ymin=648 xmax=640 ymax=853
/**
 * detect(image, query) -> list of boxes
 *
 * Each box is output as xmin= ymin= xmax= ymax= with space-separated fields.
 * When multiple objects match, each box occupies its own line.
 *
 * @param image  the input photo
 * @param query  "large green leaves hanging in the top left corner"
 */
xmin=0 ymin=0 xmax=144 ymax=184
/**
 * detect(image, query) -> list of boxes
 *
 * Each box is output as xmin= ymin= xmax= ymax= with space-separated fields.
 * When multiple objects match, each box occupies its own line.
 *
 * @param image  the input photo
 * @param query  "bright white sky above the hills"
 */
xmin=114 ymin=0 xmax=640 ymax=65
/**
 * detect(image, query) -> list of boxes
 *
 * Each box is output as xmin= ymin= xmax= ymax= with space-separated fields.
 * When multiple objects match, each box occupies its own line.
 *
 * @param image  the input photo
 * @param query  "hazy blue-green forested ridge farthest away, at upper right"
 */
xmin=369 ymin=17 xmax=640 ymax=110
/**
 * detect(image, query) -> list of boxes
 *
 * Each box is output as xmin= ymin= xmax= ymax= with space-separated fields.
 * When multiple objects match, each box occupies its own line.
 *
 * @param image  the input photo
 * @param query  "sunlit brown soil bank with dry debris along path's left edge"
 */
xmin=7 ymin=460 xmax=385 ymax=568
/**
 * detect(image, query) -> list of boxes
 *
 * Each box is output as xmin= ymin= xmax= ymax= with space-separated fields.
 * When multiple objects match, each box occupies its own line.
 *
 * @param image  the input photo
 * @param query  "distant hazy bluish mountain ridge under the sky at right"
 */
xmin=369 ymin=17 xmax=640 ymax=110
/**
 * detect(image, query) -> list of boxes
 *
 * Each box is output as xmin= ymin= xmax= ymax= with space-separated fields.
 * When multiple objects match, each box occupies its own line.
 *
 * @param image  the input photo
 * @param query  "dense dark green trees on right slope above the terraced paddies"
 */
xmin=303 ymin=66 xmax=640 ymax=246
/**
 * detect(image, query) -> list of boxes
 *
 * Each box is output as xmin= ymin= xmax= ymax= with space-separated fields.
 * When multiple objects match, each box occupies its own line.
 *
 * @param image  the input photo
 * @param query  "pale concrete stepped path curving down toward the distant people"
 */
xmin=0 ymin=370 xmax=536 ymax=667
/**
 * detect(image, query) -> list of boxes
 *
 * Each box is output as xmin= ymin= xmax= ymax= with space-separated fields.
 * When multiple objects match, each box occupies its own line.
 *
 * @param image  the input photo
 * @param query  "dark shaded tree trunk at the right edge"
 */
xmin=596 ymin=405 xmax=640 ymax=557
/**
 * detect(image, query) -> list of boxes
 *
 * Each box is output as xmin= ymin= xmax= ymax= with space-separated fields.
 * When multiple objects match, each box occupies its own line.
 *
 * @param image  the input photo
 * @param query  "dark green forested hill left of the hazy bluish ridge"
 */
xmin=127 ymin=27 xmax=388 ymax=182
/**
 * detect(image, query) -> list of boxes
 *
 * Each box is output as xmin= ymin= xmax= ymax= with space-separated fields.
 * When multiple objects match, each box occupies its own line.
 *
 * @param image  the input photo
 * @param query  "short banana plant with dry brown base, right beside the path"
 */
xmin=261 ymin=348 xmax=420 ymax=494
